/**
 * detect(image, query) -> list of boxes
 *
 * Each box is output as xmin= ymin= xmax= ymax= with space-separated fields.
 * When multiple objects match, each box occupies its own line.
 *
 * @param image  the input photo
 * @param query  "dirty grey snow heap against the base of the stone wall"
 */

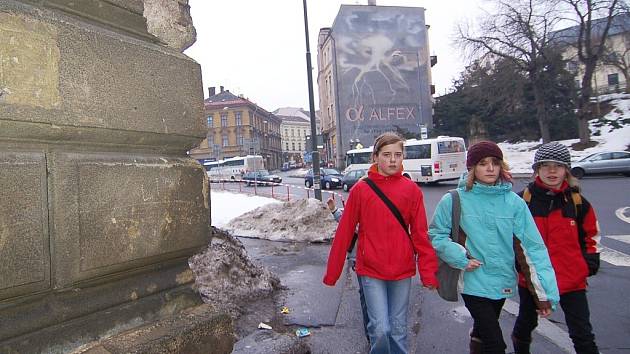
xmin=188 ymin=227 xmax=280 ymax=314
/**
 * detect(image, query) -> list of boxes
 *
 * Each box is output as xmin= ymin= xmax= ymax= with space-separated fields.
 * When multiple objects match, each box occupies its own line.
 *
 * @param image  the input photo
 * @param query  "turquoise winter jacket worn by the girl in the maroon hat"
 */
xmin=429 ymin=173 xmax=559 ymax=309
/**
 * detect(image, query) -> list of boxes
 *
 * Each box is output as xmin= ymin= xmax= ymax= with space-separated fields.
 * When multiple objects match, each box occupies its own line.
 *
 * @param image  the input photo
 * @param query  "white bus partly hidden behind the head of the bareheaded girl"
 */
xmin=344 ymin=136 xmax=466 ymax=183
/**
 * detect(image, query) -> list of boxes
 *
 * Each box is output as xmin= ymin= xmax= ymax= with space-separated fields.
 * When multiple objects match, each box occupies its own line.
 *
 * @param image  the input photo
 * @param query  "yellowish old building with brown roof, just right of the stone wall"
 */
xmin=189 ymin=86 xmax=282 ymax=170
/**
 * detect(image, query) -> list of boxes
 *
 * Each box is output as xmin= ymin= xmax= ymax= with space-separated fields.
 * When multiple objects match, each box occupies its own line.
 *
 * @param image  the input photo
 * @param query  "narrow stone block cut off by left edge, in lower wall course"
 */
xmin=0 ymin=151 xmax=50 ymax=300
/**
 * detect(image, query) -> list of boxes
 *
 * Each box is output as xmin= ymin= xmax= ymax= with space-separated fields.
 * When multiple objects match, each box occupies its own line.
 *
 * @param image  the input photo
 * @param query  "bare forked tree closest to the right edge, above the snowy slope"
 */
xmin=561 ymin=0 xmax=627 ymax=146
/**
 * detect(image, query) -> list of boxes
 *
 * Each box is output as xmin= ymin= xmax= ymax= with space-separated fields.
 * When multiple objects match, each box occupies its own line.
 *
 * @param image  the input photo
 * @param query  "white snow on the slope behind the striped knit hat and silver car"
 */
xmin=499 ymin=94 xmax=630 ymax=173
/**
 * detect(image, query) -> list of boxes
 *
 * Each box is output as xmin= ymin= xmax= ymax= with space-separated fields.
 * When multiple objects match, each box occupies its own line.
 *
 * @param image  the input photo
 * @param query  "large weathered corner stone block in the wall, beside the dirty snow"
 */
xmin=50 ymin=153 xmax=210 ymax=288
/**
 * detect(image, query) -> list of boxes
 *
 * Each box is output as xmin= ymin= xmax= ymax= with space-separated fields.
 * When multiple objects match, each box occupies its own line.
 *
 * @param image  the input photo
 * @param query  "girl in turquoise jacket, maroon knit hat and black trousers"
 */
xmin=429 ymin=141 xmax=559 ymax=353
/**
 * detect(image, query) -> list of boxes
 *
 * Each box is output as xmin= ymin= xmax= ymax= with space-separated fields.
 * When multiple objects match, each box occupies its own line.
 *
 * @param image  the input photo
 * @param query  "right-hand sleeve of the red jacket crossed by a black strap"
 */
xmin=411 ymin=186 xmax=439 ymax=287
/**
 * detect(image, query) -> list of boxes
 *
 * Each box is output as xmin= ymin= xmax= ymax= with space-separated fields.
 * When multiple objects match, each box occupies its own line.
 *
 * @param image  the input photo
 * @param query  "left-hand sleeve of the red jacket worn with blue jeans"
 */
xmin=323 ymin=184 xmax=361 ymax=286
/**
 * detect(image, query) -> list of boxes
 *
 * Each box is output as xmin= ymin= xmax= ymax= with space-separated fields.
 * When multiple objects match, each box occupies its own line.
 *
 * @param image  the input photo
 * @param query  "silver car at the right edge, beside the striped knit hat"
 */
xmin=571 ymin=151 xmax=630 ymax=178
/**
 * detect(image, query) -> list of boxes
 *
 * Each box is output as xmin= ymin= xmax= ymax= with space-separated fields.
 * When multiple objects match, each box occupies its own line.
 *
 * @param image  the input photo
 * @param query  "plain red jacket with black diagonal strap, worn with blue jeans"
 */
xmin=323 ymin=165 xmax=438 ymax=287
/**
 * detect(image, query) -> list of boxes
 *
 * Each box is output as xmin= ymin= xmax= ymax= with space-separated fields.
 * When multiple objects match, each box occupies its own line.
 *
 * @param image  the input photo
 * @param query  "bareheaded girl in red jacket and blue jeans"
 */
xmin=324 ymin=133 xmax=438 ymax=354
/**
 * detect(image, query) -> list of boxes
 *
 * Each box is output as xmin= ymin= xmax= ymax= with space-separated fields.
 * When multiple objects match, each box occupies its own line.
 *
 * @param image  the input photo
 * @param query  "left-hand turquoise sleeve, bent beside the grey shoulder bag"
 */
xmin=429 ymin=193 xmax=468 ymax=269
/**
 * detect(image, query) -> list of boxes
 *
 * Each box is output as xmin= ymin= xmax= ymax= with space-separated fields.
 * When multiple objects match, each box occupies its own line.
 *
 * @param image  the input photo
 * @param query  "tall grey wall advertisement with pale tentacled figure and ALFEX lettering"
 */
xmin=331 ymin=5 xmax=431 ymax=158
